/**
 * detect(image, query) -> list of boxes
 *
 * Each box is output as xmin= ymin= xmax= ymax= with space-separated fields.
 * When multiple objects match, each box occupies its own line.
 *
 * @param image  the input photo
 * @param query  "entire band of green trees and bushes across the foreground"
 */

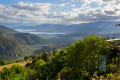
xmin=0 ymin=35 xmax=120 ymax=80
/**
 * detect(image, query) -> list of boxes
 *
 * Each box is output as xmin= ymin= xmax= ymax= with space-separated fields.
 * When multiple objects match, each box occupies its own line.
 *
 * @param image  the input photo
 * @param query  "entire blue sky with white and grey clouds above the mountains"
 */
xmin=0 ymin=0 xmax=120 ymax=26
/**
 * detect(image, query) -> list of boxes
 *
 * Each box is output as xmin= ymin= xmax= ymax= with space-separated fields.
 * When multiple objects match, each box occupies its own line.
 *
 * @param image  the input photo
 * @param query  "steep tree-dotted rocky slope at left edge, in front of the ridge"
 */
xmin=0 ymin=36 xmax=22 ymax=56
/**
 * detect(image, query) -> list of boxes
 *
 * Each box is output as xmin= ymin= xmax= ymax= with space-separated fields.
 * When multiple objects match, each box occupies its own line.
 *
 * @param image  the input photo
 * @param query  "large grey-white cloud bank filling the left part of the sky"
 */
xmin=0 ymin=2 xmax=52 ymax=23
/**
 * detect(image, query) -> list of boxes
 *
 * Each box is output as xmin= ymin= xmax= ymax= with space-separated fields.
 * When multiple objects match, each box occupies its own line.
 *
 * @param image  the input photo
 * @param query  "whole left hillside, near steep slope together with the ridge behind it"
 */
xmin=0 ymin=26 xmax=42 ymax=60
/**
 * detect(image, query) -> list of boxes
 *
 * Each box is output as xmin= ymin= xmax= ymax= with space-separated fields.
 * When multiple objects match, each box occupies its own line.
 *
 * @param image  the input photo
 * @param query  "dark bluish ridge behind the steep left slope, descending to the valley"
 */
xmin=0 ymin=26 xmax=42 ymax=45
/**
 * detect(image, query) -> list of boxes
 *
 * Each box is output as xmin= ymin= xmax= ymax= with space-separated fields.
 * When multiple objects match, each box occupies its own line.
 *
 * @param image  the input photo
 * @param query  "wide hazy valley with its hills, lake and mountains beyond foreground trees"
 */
xmin=0 ymin=22 xmax=120 ymax=61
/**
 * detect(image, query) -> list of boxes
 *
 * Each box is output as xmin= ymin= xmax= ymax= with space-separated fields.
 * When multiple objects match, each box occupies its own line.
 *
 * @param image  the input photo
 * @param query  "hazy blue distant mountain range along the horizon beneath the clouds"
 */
xmin=14 ymin=21 xmax=120 ymax=34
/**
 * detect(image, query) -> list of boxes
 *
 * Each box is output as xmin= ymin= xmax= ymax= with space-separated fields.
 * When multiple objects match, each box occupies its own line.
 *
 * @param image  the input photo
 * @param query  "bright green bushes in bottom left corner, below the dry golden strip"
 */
xmin=0 ymin=64 xmax=34 ymax=80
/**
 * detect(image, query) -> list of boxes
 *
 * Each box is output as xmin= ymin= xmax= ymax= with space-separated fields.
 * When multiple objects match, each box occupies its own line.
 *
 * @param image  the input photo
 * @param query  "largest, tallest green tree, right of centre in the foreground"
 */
xmin=67 ymin=35 xmax=111 ymax=78
